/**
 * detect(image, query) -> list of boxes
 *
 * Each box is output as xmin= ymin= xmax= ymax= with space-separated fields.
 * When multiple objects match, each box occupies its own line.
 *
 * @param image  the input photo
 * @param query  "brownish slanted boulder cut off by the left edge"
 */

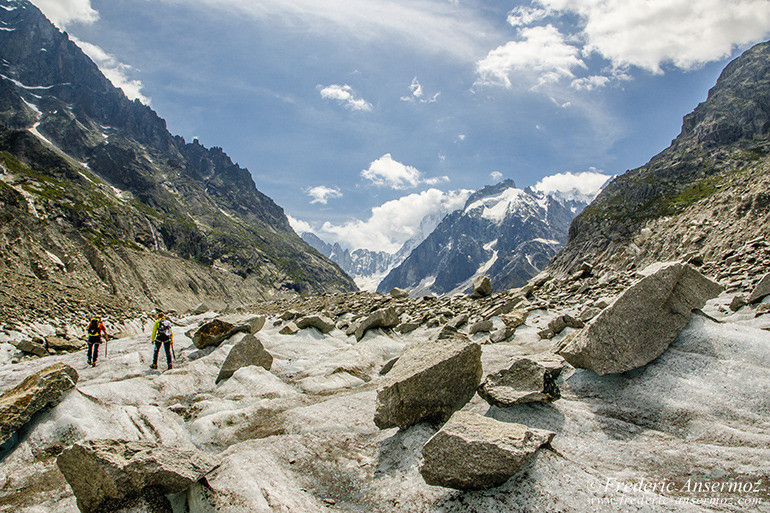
xmin=0 ymin=363 xmax=78 ymax=443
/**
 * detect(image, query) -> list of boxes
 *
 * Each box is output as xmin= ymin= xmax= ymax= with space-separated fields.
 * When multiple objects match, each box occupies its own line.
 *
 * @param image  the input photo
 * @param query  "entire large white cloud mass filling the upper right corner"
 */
xmin=476 ymin=0 xmax=770 ymax=91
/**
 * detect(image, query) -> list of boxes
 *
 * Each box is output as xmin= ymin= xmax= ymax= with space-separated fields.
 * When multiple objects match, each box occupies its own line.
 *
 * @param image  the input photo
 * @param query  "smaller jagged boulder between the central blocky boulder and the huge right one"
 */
xmin=478 ymin=356 xmax=564 ymax=408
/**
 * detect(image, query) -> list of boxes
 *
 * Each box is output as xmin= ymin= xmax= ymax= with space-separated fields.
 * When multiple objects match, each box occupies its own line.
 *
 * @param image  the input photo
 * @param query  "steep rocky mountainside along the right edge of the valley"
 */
xmin=549 ymin=43 xmax=770 ymax=273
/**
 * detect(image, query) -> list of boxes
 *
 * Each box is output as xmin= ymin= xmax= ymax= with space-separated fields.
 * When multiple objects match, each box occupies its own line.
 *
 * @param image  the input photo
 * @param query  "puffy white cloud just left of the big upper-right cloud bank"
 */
xmin=476 ymin=25 xmax=586 ymax=88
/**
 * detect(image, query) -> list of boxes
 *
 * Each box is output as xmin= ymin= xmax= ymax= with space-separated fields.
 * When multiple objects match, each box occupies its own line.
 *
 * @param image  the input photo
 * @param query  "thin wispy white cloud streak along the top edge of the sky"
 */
xmin=165 ymin=0 xmax=499 ymax=62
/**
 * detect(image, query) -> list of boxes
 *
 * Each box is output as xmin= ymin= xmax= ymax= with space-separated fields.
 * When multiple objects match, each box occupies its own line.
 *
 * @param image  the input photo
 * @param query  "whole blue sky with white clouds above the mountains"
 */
xmin=32 ymin=0 xmax=770 ymax=252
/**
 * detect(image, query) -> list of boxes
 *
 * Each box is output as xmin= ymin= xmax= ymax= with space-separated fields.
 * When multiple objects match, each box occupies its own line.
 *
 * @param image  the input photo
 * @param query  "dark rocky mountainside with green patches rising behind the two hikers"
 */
xmin=0 ymin=0 xmax=355 ymax=317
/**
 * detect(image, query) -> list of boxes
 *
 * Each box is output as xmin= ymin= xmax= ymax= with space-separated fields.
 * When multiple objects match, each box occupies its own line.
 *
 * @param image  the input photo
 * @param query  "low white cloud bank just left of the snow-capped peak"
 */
xmin=321 ymin=189 xmax=472 ymax=253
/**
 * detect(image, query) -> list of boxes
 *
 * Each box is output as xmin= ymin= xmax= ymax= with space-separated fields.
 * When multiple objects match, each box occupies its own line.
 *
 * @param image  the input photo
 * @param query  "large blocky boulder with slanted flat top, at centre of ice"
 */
xmin=374 ymin=334 xmax=482 ymax=429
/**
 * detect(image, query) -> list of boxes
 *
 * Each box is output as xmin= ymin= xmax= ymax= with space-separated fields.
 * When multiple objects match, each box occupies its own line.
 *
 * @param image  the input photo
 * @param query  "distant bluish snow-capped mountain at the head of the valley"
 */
xmin=377 ymin=180 xmax=584 ymax=295
